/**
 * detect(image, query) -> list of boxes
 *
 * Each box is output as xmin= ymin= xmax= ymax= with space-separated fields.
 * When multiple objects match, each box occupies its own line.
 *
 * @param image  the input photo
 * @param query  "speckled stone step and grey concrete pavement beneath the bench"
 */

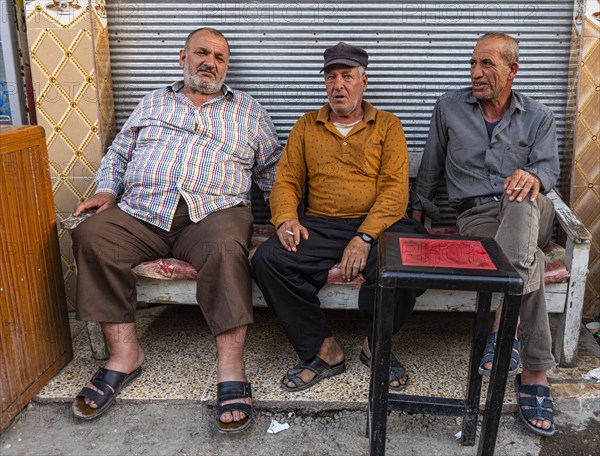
xmin=0 ymin=306 xmax=600 ymax=456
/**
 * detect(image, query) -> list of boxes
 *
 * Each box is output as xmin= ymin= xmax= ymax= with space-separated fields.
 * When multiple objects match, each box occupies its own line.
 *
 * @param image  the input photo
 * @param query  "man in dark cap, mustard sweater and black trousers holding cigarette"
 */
xmin=252 ymin=42 xmax=425 ymax=391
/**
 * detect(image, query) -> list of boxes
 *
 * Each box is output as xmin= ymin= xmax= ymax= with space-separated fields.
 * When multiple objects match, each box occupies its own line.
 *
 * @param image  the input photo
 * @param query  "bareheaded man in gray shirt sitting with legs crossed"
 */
xmin=411 ymin=33 xmax=560 ymax=436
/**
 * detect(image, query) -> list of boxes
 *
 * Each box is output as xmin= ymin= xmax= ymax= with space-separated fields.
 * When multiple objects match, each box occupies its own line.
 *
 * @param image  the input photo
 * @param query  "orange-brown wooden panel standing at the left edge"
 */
xmin=0 ymin=126 xmax=72 ymax=429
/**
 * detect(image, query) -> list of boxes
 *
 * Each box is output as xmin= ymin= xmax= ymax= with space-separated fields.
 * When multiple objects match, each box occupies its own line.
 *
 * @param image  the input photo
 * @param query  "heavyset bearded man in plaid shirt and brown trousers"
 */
xmin=73 ymin=28 xmax=281 ymax=432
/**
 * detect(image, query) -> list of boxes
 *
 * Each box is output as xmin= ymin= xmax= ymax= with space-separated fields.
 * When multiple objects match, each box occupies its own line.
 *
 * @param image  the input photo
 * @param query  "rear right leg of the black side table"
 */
xmin=460 ymin=293 xmax=492 ymax=446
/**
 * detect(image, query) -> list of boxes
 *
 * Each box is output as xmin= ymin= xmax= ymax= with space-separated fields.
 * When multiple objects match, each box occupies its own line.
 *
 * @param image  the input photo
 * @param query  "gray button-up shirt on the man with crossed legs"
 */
xmin=411 ymin=87 xmax=560 ymax=219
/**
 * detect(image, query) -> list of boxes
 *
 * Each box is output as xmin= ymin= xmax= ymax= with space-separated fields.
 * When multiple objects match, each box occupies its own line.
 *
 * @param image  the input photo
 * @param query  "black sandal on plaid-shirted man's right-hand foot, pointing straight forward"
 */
xmin=217 ymin=381 xmax=252 ymax=434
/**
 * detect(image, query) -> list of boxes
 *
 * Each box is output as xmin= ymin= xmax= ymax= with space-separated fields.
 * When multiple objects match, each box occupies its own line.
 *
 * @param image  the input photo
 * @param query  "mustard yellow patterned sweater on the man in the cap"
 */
xmin=270 ymin=101 xmax=408 ymax=238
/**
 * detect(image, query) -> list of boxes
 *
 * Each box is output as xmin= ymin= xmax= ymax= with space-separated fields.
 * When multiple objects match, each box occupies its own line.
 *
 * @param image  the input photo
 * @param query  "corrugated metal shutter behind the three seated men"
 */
xmin=107 ymin=0 xmax=574 ymax=225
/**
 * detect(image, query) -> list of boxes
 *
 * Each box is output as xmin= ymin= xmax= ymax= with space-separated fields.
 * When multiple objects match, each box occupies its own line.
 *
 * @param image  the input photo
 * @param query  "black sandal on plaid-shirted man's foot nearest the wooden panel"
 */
xmin=71 ymin=366 xmax=142 ymax=420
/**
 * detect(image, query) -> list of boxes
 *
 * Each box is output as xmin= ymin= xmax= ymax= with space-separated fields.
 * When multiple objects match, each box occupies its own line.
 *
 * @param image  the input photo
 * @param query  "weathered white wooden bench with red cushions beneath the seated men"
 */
xmin=82 ymin=159 xmax=591 ymax=366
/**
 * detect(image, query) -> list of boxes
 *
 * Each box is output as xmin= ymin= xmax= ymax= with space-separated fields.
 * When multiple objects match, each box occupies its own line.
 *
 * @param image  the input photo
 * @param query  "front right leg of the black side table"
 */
xmin=477 ymin=294 xmax=522 ymax=456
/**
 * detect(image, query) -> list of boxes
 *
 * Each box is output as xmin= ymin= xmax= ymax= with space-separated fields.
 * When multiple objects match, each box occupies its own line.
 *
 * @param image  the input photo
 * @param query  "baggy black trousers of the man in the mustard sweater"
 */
xmin=252 ymin=217 xmax=426 ymax=361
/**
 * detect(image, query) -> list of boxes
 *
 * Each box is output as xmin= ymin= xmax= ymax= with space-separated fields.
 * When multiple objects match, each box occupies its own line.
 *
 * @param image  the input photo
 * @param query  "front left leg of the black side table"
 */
xmin=367 ymin=286 xmax=396 ymax=456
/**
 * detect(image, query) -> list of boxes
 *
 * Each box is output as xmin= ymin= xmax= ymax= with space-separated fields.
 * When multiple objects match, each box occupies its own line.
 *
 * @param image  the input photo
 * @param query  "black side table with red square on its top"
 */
xmin=367 ymin=233 xmax=523 ymax=455
